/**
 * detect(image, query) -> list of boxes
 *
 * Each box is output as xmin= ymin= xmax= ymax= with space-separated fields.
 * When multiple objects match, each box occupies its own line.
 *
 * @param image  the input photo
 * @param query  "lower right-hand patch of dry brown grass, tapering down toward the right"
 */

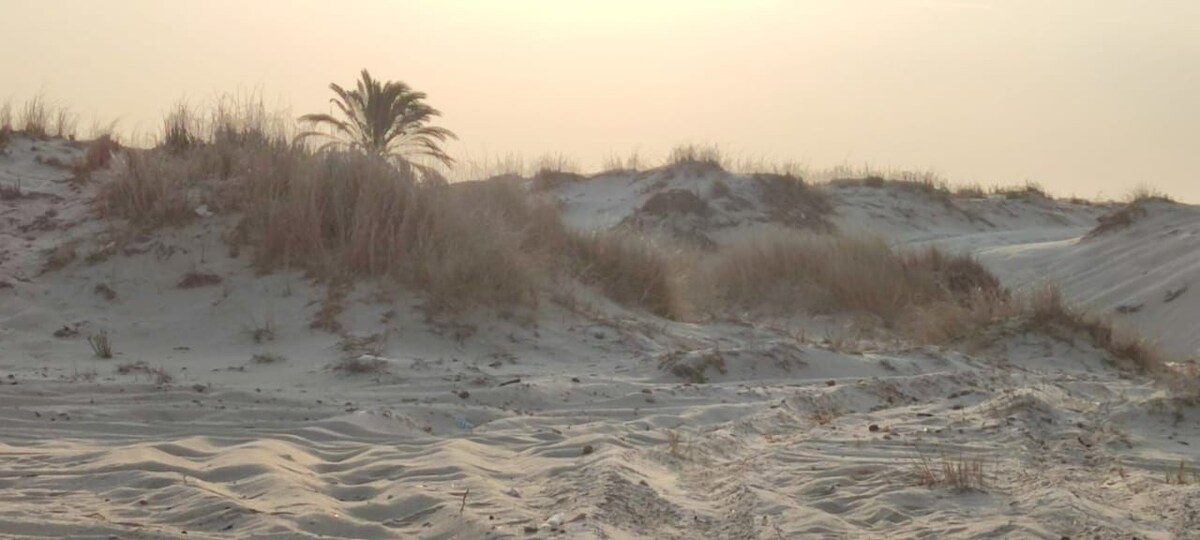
xmin=689 ymin=232 xmax=1165 ymax=372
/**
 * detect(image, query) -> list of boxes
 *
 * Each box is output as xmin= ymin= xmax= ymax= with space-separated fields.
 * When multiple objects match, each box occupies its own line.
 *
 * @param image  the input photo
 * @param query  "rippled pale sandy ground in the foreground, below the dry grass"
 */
xmin=0 ymin=140 xmax=1200 ymax=539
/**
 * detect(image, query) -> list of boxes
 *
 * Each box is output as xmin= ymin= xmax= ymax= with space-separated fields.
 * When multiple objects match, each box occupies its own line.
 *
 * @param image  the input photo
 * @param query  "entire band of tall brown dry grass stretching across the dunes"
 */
xmin=88 ymin=97 xmax=1176 ymax=370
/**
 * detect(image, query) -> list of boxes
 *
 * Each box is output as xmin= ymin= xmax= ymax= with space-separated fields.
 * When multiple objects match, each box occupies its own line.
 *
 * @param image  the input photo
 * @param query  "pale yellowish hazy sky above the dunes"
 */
xmin=0 ymin=0 xmax=1200 ymax=202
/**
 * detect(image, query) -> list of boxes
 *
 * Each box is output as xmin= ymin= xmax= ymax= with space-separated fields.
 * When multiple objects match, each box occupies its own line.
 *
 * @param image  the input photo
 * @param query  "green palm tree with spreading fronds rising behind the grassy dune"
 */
xmin=298 ymin=70 xmax=458 ymax=172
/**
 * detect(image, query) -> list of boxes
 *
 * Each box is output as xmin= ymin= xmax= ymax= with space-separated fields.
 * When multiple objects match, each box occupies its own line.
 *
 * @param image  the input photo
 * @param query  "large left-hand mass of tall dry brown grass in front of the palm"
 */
xmin=97 ymin=99 xmax=683 ymax=317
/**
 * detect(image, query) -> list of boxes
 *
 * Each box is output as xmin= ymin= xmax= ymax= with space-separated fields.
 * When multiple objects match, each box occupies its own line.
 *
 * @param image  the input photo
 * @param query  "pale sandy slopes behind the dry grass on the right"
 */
xmin=557 ymin=167 xmax=1200 ymax=358
